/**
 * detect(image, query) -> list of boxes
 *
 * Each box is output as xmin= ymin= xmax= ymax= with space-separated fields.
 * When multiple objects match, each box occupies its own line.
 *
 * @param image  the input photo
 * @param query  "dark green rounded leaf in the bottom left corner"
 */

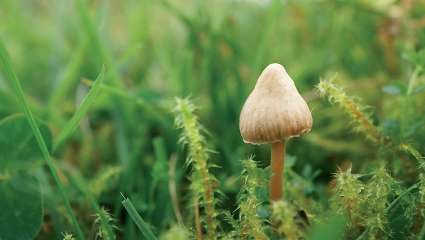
xmin=0 ymin=174 xmax=43 ymax=240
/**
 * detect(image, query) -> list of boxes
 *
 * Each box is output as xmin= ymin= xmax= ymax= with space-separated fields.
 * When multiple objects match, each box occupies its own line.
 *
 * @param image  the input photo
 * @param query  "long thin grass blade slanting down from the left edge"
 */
xmin=0 ymin=39 xmax=84 ymax=239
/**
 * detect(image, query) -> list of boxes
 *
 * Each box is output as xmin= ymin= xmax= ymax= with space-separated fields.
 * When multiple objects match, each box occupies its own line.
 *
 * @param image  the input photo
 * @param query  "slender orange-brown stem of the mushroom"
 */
xmin=270 ymin=141 xmax=285 ymax=202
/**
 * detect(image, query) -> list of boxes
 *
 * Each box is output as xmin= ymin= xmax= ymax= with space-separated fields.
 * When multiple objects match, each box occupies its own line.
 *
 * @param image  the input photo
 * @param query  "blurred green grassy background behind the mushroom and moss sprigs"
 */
xmin=0 ymin=0 xmax=425 ymax=239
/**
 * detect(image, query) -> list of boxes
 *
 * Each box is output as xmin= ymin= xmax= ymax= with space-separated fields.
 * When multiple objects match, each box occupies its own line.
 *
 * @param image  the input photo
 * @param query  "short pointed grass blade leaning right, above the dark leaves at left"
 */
xmin=53 ymin=67 xmax=105 ymax=150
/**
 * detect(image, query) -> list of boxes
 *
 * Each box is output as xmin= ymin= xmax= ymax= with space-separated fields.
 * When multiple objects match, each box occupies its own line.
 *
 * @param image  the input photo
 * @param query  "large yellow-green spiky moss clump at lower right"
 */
xmin=332 ymin=166 xmax=401 ymax=239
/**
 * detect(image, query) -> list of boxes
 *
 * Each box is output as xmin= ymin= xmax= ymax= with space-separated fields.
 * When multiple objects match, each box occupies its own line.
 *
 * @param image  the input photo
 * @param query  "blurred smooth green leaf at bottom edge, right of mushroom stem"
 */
xmin=307 ymin=214 xmax=347 ymax=240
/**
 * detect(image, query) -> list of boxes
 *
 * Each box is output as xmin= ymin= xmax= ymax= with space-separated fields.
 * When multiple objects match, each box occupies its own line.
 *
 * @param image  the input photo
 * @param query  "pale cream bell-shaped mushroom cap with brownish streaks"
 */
xmin=239 ymin=63 xmax=313 ymax=144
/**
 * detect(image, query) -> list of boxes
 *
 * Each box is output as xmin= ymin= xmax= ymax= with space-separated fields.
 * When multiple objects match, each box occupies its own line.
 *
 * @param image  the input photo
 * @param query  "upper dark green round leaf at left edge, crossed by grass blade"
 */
xmin=0 ymin=114 xmax=52 ymax=172
